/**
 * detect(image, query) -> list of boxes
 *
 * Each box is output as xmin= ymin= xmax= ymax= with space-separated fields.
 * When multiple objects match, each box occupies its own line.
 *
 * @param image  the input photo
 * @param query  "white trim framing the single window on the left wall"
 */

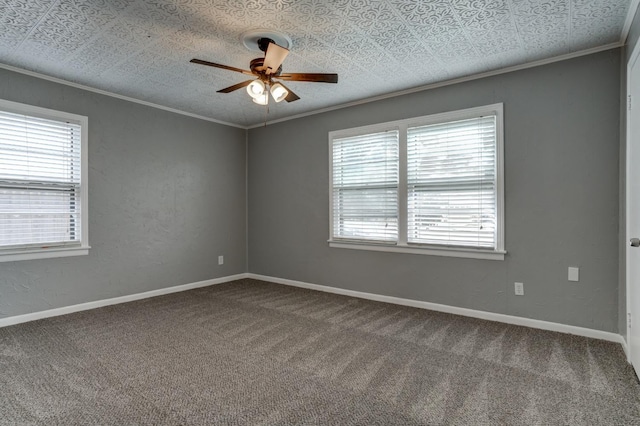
xmin=0 ymin=99 xmax=91 ymax=262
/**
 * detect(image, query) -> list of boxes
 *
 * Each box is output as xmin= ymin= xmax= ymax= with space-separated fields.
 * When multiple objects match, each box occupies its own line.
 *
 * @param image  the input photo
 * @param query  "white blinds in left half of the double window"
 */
xmin=332 ymin=130 xmax=399 ymax=242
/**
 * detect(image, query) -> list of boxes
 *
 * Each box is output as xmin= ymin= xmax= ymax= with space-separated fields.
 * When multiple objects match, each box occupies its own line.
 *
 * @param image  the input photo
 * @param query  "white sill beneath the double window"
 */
xmin=329 ymin=240 xmax=507 ymax=260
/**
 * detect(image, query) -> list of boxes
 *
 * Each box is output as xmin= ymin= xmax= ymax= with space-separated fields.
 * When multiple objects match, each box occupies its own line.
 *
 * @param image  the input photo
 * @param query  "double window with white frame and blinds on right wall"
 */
xmin=329 ymin=104 xmax=505 ymax=260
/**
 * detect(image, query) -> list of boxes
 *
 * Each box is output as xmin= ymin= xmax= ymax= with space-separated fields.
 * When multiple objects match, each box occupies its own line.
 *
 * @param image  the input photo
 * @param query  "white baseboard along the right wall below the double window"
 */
xmin=247 ymin=273 xmax=626 ymax=346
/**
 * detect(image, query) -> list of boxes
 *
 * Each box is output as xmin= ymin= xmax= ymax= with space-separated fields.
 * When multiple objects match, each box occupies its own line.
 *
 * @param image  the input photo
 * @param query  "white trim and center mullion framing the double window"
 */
xmin=328 ymin=103 xmax=507 ymax=260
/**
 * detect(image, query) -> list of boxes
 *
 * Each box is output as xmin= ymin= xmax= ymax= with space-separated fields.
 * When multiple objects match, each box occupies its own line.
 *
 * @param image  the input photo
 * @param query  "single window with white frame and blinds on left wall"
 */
xmin=0 ymin=100 xmax=89 ymax=261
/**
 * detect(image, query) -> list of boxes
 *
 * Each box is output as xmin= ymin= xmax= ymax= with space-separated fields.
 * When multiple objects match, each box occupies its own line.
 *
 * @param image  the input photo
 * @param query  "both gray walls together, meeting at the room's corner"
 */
xmin=0 ymin=47 xmax=624 ymax=333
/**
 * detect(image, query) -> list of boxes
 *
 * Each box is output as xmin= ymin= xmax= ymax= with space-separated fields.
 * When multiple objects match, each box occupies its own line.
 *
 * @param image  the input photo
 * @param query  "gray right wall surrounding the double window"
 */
xmin=249 ymin=49 xmax=621 ymax=332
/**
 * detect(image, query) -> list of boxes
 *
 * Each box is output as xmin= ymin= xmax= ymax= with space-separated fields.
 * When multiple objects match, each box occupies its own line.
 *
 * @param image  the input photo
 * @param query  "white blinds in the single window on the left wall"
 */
xmin=0 ymin=111 xmax=82 ymax=249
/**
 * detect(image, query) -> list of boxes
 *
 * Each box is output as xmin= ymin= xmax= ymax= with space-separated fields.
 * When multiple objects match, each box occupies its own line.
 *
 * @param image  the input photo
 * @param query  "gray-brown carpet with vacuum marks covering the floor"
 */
xmin=0 ymin=280 xmax=640 ymax=425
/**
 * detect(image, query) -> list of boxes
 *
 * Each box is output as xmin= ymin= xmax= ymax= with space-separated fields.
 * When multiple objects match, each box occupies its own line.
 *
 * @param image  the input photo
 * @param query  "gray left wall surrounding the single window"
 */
xmin=0 ymin=70 xmax=246 ymax=318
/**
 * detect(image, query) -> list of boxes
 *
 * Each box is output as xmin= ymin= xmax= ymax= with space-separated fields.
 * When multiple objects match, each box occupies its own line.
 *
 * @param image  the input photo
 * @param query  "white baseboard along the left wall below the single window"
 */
xmin=0 ymin=274 xmax=248 ymax=327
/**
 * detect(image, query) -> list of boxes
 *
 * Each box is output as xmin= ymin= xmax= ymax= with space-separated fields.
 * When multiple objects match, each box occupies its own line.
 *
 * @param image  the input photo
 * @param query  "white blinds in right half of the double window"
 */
xmin=407 ymin=115 xmax=497 ymax=249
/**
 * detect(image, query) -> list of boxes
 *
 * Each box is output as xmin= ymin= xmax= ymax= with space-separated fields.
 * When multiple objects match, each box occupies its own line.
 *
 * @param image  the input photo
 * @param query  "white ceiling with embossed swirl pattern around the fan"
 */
xmin=0 ymin=0 xmax=631 ymax=126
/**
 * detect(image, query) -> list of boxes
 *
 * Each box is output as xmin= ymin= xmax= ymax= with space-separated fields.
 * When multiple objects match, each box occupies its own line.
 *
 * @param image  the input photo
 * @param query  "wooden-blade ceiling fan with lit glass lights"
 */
xmin=190 ymin=37 xmax=338 ymax=105
